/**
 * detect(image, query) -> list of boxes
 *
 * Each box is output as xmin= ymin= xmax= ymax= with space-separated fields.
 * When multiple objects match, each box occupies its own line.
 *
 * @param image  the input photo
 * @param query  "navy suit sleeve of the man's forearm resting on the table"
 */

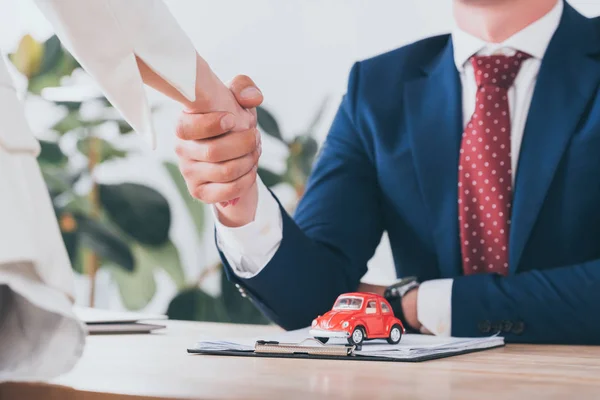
xmin=452 ymin=260 xmax=600 ymax=344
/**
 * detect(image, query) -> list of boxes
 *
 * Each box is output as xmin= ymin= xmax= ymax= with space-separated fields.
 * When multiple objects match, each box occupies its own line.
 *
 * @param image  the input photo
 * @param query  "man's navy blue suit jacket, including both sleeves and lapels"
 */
xmin=223 ymin=4 xmax=600 ymax=343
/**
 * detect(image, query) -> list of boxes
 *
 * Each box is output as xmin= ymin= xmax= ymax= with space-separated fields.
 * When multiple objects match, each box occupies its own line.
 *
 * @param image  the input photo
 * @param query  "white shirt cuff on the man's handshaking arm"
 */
xmin=211 ymin=178 xmax=283 ymax=279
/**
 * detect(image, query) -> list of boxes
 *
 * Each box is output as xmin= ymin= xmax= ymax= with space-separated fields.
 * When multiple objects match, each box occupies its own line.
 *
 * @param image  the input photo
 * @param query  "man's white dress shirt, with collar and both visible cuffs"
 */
xmin=215 ymin=0 xmax=564 ymax=336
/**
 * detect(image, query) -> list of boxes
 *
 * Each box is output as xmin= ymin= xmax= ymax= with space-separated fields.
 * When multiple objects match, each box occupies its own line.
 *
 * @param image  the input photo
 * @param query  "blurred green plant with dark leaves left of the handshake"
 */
xmin=9 ymin=35 xmax=185 ymax=309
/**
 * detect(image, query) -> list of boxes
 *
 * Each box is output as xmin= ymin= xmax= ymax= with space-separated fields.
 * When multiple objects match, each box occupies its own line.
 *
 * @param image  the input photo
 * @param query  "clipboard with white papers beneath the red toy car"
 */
xmin=188 ymin=328 xmax=504 ymax=362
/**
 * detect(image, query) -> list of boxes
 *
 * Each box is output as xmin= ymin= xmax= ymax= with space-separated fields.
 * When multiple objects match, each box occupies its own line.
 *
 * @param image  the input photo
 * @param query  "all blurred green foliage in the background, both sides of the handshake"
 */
xmin=9 ymin=35 xmax=325 ymax=323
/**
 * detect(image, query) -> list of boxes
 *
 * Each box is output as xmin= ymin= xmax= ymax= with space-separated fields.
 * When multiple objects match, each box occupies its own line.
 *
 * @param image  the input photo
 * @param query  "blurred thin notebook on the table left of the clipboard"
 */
xmin=73 ymin=306 xmax=168 ymax=335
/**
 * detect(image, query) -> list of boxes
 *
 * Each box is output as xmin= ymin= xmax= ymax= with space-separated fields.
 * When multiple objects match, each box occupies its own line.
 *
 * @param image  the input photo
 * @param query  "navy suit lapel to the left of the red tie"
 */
xmin=404 ymin=39 xmax=463 ymax=276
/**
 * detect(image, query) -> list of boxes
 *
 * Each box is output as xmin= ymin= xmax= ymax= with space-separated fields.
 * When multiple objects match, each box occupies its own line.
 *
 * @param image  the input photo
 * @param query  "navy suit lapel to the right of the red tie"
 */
xmin=509 ymin=4 xmax=600 ymax=273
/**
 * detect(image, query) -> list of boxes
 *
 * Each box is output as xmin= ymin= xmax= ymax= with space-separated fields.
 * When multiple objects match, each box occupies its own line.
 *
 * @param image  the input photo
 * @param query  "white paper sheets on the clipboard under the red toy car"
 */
xmin=189 ymin=328 xmax=504 ymax=361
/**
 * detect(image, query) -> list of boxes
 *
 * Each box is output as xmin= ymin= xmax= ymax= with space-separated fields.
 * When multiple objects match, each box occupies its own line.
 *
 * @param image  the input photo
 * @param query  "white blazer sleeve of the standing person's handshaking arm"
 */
xmin=35 ymin=0 xmax=196 ymax=148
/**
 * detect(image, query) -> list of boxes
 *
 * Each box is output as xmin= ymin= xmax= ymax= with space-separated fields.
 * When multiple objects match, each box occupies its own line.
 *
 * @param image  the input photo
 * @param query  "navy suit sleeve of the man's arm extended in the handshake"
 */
xmin=222 ymin=64 xmax=383 ymax=329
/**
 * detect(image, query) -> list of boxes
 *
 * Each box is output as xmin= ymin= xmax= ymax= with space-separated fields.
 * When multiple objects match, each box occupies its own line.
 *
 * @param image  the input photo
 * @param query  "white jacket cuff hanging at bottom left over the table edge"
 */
xmin=0 ymin=263 xmax=86 ymax=383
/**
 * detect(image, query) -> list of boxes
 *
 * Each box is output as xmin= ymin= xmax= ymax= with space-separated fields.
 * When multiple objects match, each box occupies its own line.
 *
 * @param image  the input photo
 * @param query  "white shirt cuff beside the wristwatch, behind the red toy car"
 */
xmin=417 ymin=279 xmax=453 ymax=336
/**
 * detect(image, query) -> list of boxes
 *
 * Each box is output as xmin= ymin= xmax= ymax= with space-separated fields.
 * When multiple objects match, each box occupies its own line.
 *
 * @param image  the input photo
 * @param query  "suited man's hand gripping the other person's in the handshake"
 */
xmin=175 ymin=76 xmax=263 ymax=226
